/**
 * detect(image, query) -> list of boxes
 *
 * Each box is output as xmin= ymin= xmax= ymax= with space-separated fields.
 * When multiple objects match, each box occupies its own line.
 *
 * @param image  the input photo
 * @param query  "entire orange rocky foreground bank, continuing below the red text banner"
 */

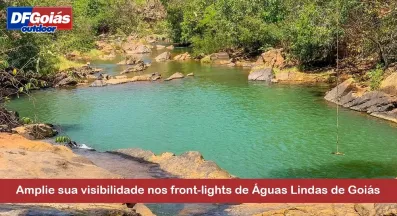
xmin=0 ymin=133 xmax=397 ymax=216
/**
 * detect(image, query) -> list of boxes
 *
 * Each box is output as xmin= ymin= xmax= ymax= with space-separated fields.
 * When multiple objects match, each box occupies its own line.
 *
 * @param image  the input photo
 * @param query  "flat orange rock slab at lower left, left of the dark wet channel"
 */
xmin=0 ymin=133 xmax=150 ymax=216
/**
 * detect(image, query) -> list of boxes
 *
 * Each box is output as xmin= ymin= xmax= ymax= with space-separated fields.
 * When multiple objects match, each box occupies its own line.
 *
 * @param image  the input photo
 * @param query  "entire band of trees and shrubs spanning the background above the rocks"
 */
xmin=0 ymin=0 xmax=397 ymax=80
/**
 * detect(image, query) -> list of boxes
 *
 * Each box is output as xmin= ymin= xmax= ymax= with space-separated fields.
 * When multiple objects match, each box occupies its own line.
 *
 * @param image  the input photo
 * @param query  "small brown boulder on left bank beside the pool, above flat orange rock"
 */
xmin=12 ymin=124 xmax=58 ymax=139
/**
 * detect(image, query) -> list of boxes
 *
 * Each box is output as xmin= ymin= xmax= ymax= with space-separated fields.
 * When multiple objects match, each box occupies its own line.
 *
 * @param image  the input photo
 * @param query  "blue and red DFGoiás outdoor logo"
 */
xmin=7 ymin=7 xmax=72 ymax=33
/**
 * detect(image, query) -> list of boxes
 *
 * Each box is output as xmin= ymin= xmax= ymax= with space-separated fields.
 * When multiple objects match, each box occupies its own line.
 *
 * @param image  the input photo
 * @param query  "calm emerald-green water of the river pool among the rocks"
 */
xmin=5 ymin=49 xmax=397 ymax=178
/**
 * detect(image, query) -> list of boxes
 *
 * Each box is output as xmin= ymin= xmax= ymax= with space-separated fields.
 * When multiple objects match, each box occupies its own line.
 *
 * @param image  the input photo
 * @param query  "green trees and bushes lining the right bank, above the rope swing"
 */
xmin=163 ymin=0 xmax=397 ymax=68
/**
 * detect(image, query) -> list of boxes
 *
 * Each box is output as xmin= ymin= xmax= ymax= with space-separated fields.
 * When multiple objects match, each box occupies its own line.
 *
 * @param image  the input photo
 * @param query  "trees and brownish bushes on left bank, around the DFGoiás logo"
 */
xmin=0 ymin=0 xmax=166 ymax=74
